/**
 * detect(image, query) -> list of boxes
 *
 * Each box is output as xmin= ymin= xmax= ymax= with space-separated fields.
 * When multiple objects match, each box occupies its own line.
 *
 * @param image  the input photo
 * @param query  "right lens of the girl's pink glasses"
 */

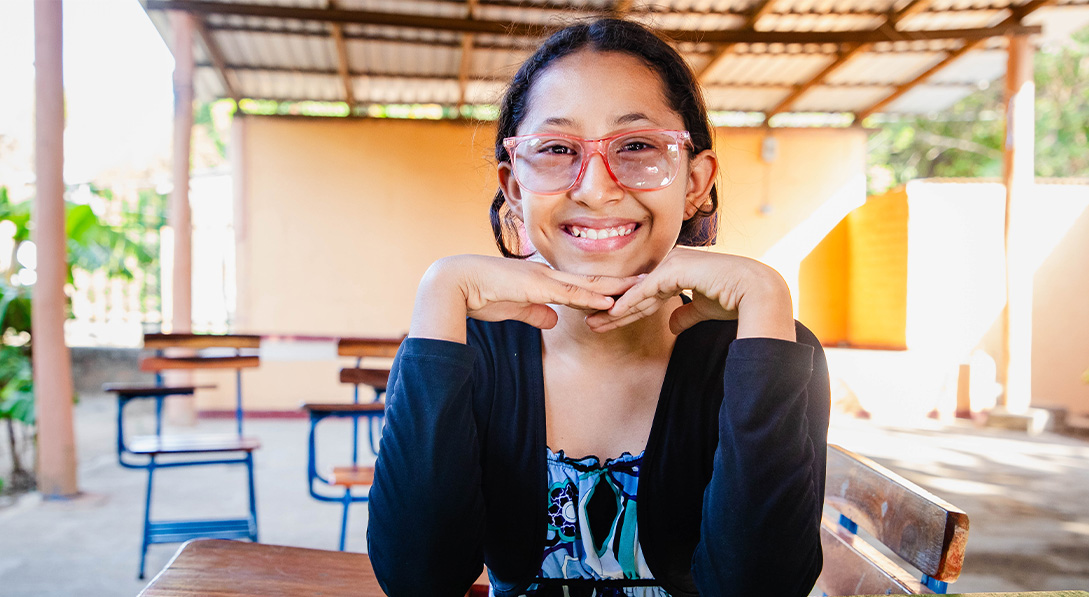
xmin=609 ymin=132 xmax=681 ymax=190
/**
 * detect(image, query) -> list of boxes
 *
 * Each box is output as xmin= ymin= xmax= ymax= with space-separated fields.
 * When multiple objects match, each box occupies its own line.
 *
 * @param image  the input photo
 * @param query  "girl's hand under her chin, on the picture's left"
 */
xmin=408 ymin=255 xmax=638 ymax=342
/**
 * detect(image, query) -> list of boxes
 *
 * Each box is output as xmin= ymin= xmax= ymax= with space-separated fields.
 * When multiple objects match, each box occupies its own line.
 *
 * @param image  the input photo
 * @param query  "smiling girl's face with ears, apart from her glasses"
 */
xmin=499 ymin=50 xmax=718 ymax=277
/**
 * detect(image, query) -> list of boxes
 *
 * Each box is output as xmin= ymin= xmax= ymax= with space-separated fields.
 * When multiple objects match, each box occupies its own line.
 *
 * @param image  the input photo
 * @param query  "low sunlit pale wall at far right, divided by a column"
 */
xmin=892 ymin=181 xmax=1089 ymax=414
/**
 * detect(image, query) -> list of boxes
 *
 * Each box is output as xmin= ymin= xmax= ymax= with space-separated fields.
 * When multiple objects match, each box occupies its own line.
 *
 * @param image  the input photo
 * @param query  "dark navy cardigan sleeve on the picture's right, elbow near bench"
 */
xmin=693 ymin=326 xmax=830 ymax=597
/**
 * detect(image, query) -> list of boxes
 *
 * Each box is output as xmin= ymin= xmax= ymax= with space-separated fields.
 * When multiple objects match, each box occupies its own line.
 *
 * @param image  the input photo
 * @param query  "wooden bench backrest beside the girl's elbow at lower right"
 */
xmin=817 ymin=446 xmax=968 ymax=596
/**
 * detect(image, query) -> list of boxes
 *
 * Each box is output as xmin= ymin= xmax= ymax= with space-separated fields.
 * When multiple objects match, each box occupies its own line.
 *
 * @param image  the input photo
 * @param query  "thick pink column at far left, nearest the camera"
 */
xmin=32 ymin=0 xmax=79 ymax=499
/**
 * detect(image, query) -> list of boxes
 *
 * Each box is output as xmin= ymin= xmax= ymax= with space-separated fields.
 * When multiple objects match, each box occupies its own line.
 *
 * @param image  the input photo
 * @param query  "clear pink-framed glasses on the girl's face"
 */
xmin=503 ymin=129 xmax=692 ymax=195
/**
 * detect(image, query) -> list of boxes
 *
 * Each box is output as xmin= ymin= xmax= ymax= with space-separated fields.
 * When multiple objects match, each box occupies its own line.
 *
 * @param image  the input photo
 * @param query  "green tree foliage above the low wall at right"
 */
xmin=867 ymin=27 xmax=1089 ymax=193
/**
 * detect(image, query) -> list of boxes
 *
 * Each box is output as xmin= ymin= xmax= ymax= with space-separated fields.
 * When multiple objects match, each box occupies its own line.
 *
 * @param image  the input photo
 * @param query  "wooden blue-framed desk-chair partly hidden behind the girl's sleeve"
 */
xmin=303 ymin=338 xmax=403 ymax=551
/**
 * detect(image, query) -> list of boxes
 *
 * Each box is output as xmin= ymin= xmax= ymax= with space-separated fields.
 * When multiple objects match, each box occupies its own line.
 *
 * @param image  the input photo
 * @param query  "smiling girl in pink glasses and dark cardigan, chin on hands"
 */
xmin=368 ymin=20 xmax=829 ymax=597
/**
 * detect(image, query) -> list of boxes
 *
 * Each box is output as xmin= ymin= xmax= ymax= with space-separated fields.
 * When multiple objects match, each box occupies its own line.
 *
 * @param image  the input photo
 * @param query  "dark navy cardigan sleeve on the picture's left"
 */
xmin=367 ymin=338 xmax=485 ymax=597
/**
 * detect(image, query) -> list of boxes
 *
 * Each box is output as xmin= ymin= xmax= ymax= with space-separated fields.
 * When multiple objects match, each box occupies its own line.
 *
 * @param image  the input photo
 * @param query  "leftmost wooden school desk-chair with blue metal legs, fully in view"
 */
xmin=103 ymin=333 xmax=260 ymax=578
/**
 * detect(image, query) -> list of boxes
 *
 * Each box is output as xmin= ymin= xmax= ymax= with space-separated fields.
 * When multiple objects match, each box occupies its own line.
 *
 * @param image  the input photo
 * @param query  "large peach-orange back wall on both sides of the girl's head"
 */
xmin=199 ymin=118 xmax=866 ymax=410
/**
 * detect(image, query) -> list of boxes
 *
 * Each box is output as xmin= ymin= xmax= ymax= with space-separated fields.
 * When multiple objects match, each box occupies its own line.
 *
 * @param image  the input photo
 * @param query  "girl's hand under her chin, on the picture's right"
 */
xmin=586 ymin=247 xmax=796 ymax=341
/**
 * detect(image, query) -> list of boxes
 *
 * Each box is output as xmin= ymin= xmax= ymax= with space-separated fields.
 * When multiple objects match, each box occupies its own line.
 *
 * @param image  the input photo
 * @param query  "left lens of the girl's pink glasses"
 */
xmin=514 ymin=135 xmax=583 ymax=193
